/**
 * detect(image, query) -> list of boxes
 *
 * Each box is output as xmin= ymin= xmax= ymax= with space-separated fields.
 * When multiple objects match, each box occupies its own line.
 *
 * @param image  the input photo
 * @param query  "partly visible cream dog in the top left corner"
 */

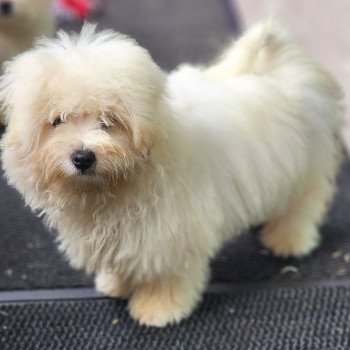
xmin=0 ymin=0 xmax=55 ymax=120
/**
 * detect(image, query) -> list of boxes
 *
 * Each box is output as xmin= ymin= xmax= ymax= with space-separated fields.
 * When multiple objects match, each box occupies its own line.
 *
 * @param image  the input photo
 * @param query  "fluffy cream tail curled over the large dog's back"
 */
xmin=203 ymin=19 xmax=343 ymax=126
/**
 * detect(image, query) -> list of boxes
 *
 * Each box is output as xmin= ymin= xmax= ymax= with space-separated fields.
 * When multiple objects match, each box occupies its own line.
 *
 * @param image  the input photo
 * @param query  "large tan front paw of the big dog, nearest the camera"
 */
xmin=129 ymin=285 xmax=193 ymax=327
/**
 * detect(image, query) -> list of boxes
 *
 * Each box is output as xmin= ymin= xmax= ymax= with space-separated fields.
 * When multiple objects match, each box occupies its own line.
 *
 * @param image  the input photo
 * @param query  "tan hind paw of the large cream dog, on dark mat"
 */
xmin=260 ymin=224 xmax=320 ymax=258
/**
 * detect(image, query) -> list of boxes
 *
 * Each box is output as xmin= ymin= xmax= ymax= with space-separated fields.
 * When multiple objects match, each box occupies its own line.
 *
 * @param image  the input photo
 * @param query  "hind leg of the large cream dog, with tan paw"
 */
xmin=261 ymin=171 xmax=335 ymax=258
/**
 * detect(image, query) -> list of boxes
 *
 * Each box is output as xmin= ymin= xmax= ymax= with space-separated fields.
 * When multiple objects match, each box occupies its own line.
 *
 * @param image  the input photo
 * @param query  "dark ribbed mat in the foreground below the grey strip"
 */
xmin=0 ymin=286 xmax=350 ymax=350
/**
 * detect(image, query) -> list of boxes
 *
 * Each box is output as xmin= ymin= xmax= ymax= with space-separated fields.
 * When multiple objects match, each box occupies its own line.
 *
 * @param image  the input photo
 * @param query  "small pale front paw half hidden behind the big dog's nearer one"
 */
xmin=95 ymin=272 xmax=130 ymax=298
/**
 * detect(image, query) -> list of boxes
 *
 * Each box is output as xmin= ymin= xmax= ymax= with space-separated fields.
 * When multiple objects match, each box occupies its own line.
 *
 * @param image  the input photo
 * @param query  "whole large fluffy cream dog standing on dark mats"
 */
xmin=0 ymin=21 xmax=342 ymax=326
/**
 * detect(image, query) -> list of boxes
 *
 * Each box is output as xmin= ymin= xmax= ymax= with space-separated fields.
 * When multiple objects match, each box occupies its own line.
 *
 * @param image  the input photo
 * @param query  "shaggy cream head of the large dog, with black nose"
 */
xmin=0 ymin=25 xmax=164 ymax=198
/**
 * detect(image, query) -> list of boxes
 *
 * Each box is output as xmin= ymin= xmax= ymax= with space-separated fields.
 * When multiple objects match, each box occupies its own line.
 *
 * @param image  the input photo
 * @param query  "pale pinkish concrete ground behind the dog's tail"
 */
xmin=230 ymin=0 xmax=350 ymax=150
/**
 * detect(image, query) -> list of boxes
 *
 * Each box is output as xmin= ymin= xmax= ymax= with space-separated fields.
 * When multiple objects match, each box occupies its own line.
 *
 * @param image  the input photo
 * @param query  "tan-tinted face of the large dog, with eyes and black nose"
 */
xmin=32 ymin=89 xmax=155 ymax=190
